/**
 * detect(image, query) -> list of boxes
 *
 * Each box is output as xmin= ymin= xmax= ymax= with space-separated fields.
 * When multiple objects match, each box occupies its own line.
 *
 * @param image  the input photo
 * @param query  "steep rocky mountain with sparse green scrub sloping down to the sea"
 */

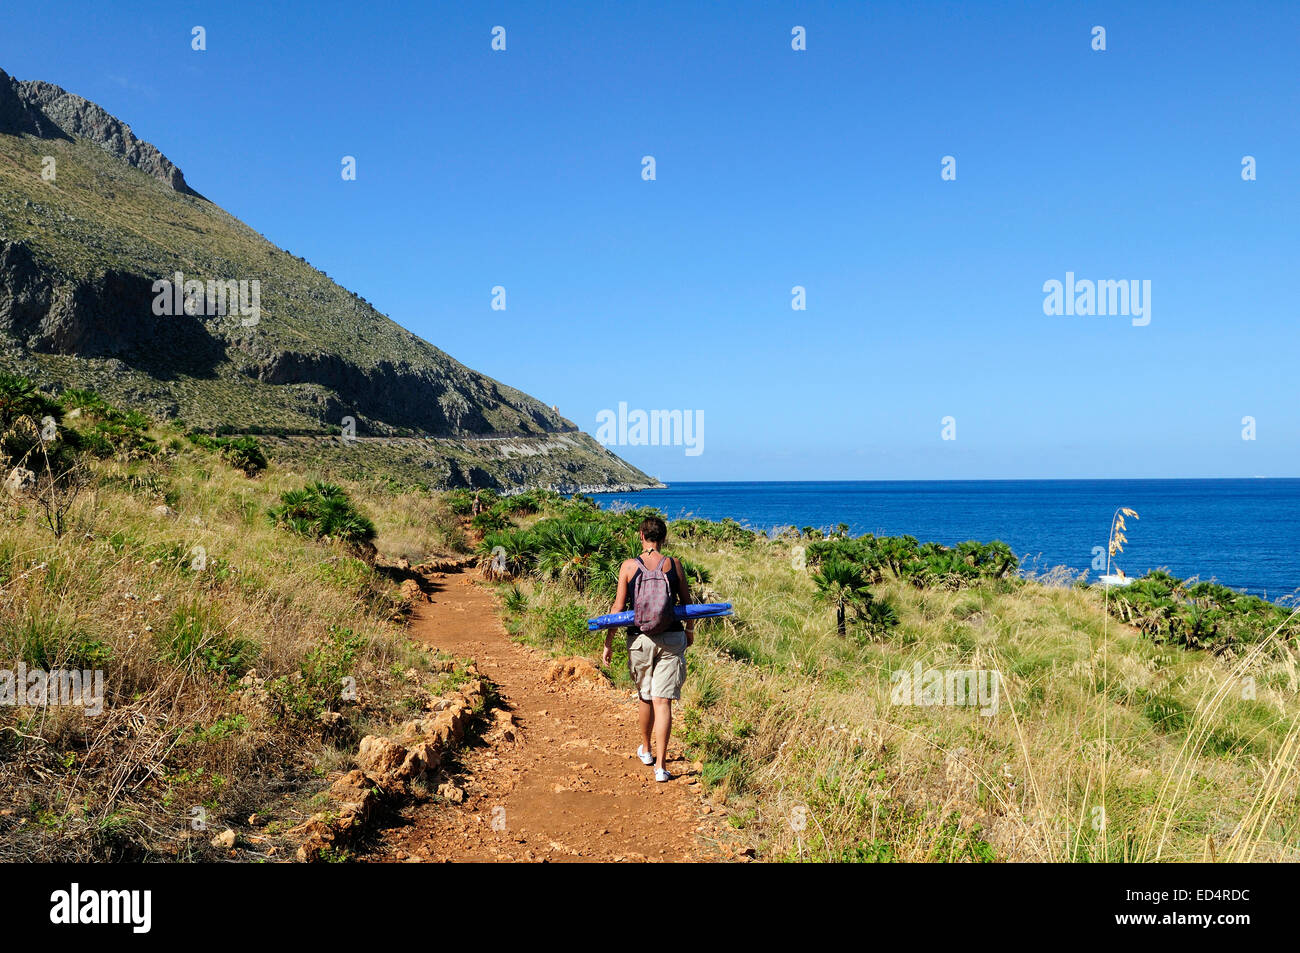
xmin=0 ymin=70 xmax=655 ymax=489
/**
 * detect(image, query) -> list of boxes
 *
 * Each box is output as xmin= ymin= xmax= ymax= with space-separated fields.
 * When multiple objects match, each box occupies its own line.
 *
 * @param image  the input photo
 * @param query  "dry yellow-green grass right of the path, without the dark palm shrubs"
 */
xmin=499 ymin=530 xmax=1300 ymax=862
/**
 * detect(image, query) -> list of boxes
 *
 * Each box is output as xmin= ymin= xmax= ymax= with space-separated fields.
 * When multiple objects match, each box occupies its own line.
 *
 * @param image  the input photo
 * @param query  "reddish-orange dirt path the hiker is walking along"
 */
xmin=364 ymin=572 xmax=733 ymax=862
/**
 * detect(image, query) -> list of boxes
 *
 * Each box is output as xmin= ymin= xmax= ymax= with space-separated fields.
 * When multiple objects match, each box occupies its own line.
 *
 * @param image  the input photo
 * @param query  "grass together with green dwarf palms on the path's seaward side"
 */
xmin=482 ymin=499 xmax=1300 ymax=862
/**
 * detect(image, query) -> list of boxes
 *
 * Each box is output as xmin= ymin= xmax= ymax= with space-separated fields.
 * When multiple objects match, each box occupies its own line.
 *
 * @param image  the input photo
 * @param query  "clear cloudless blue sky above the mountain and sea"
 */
xmin=0 ymin=0 xmax=1300 ymax=481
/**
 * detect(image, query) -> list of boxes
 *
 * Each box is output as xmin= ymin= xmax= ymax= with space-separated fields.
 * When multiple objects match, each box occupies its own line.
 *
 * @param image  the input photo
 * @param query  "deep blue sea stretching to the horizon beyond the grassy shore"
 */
xmin=597 ymin=480 xmax=1300 ymax=601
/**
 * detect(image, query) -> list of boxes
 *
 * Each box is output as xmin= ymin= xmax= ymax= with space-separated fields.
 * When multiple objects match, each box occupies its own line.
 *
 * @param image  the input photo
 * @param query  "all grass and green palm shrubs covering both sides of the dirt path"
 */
xmin=0 ymin=377 xmax=1300 ymax=862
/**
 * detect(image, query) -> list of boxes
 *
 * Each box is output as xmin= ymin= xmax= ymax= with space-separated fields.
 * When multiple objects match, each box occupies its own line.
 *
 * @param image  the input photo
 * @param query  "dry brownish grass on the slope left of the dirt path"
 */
xmin=0 ymin=434 xmax=459 ymax=859
